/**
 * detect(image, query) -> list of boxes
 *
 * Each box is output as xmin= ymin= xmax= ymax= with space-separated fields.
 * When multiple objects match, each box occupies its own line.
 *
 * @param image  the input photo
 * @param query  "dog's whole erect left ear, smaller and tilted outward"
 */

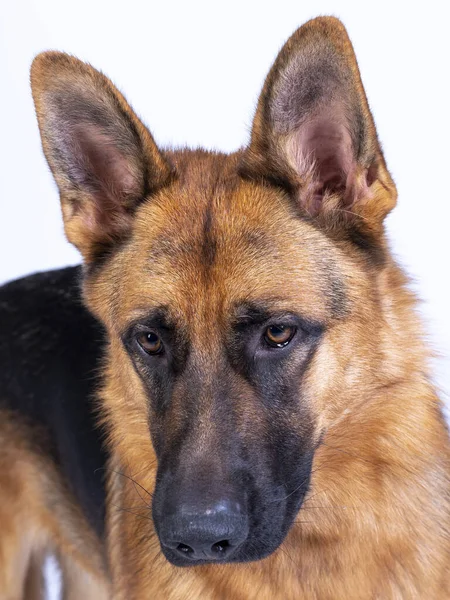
xmin=31 ymin=52 xmax=172 ymax=263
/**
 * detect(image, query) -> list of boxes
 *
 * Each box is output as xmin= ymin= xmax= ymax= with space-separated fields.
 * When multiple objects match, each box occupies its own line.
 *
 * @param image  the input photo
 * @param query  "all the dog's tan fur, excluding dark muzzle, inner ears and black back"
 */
xmin=0 ymin=18 xmax=450 ymax=600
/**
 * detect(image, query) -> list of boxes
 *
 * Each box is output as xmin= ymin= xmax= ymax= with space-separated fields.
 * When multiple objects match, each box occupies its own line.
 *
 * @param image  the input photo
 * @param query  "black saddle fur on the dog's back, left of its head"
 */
xmin=0 ymin=267 xmax=106 ymax=536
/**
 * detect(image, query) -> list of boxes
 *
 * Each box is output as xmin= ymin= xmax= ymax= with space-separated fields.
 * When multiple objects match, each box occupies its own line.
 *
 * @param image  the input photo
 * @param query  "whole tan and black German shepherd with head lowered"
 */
xmin=0 ymin=17 xmax=450 ymax=600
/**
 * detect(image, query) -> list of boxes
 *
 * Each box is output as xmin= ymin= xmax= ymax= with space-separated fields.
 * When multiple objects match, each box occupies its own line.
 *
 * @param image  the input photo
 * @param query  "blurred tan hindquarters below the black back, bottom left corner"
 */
xmin=0 ymin=411 xmax=110 ymax=600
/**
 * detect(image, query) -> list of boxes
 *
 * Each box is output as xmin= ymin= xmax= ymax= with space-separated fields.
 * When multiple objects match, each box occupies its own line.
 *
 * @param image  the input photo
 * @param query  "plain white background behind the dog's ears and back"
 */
xmin=0 ymin=0 xmax=450 ymax=596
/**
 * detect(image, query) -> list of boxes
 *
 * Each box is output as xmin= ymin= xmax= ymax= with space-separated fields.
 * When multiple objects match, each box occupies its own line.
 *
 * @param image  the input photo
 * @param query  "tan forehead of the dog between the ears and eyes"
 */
xmin=113 ymin=159 xmax=344 ymax=321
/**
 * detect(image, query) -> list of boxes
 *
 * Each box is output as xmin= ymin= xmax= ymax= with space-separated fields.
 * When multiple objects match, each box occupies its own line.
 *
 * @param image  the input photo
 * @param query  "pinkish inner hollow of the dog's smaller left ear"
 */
xmin=73 ymin=123 xmax=141 ymax=202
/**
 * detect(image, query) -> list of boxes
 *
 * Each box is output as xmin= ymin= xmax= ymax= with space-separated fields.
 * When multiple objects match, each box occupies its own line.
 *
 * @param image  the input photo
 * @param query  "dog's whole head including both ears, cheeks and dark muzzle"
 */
xmin=32 ymin=18 xmax=395 ymax=566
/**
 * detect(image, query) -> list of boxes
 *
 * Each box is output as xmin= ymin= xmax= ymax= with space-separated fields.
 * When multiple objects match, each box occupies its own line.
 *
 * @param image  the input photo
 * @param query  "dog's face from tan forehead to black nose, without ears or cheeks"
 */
xmin=112 ymin=166 xmax=330 ymax=564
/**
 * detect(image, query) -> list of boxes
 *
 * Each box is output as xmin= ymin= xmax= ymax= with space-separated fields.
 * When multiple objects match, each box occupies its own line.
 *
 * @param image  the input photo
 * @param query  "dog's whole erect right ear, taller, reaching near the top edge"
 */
xmin=241 ymin=17 xmax=396 ymax=233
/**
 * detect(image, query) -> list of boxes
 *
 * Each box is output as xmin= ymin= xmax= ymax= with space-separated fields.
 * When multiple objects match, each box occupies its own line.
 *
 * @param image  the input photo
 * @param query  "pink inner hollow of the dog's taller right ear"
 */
xmin=287 ymin=106 xmax=367 ymax=214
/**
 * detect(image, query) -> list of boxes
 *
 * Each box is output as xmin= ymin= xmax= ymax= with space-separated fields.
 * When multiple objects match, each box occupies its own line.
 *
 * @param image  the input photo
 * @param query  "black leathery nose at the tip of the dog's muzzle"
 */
xmin=159 ymin=501 xmax=248 ymax=561
